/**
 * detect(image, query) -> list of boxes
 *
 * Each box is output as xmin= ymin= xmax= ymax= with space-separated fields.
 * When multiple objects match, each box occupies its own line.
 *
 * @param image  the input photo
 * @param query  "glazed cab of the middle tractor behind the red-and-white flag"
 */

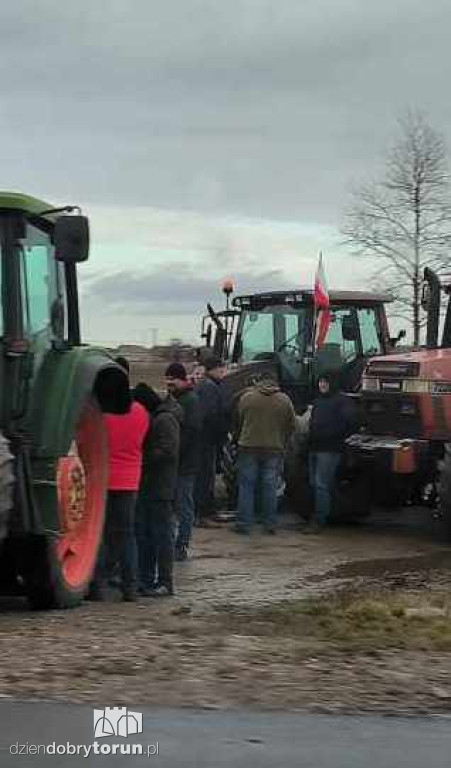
xmin=203 ymin=289 xmax=391 ymax=411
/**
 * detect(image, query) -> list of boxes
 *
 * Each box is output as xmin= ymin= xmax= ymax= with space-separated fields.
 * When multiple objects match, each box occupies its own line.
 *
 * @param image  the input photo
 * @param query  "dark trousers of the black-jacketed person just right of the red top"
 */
xmin=136 ymin=498 xmax=174 ymax=591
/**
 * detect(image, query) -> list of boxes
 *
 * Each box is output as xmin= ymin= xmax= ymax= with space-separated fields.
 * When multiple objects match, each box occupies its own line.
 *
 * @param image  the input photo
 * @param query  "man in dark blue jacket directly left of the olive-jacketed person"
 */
xmin=195 ymin=354 xmax=227 ymax=526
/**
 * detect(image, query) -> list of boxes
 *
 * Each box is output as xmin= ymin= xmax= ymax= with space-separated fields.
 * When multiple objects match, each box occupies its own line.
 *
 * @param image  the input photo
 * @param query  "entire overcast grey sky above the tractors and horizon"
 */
xmin=0 ymin=0 xmax=451 ymax=342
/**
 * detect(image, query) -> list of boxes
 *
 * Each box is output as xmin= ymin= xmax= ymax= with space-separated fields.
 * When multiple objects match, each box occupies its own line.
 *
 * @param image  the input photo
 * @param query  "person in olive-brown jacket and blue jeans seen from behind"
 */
xmin=235 ymin=374 xmax=296 ymax=534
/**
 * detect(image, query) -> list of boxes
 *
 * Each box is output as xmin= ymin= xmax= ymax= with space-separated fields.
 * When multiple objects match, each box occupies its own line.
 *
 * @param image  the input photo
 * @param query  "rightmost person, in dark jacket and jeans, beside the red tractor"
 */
xmin=305 ymin=373 xmax=356 ymax=533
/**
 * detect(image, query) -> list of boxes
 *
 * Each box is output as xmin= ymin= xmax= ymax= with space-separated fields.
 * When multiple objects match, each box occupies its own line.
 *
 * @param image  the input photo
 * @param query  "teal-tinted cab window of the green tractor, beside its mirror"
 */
xmin=21 ymin=223 xmax=59 ymax=339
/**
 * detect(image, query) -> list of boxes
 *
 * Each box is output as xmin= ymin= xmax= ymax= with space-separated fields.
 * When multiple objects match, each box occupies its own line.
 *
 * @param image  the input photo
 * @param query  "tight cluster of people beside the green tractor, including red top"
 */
xmin=89 ymin=355 xmax=227 ymax=601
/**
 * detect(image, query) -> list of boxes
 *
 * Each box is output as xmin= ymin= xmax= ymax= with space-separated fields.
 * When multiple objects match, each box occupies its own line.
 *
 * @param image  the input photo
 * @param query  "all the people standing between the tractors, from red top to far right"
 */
xmin=90 ymin=355 xmax=354 ymax=601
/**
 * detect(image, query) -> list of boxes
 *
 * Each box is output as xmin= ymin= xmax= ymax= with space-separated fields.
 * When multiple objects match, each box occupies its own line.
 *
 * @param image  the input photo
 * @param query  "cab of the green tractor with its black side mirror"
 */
xmin=0 ymin=193 xmax=89 ymax=428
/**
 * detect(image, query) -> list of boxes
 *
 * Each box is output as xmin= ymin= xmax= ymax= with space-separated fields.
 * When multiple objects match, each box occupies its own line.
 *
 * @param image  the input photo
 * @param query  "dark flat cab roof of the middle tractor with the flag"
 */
xmin=232 ymin=288 xmax=393 ymax=310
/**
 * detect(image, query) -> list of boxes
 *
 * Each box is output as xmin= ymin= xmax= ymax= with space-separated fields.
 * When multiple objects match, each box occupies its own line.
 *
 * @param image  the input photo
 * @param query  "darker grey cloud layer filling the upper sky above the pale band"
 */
xmin=0 ymin=0 xmax=451 ymax=226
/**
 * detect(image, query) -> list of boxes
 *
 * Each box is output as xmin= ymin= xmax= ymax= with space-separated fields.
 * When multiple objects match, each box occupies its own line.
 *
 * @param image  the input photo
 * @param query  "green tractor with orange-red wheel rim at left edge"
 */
xmin=0 ymin=192 xmax=130 ymax=608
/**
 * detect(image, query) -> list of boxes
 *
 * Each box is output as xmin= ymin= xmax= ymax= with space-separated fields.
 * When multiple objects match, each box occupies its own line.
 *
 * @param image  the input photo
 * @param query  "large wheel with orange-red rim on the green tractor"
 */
xmin=22 ymin=400 xmax=108 ymax=609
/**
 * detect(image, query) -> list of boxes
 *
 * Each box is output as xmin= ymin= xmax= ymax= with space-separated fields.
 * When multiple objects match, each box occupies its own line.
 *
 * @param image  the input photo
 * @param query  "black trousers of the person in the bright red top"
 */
xmin=94 ymin=491 xmax=137 ymax=592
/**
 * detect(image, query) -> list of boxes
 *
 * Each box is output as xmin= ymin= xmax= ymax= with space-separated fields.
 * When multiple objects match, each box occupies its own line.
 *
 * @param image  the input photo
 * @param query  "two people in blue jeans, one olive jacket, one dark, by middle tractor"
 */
xmin=235 ymin=373 xmax=356 ymax=535
